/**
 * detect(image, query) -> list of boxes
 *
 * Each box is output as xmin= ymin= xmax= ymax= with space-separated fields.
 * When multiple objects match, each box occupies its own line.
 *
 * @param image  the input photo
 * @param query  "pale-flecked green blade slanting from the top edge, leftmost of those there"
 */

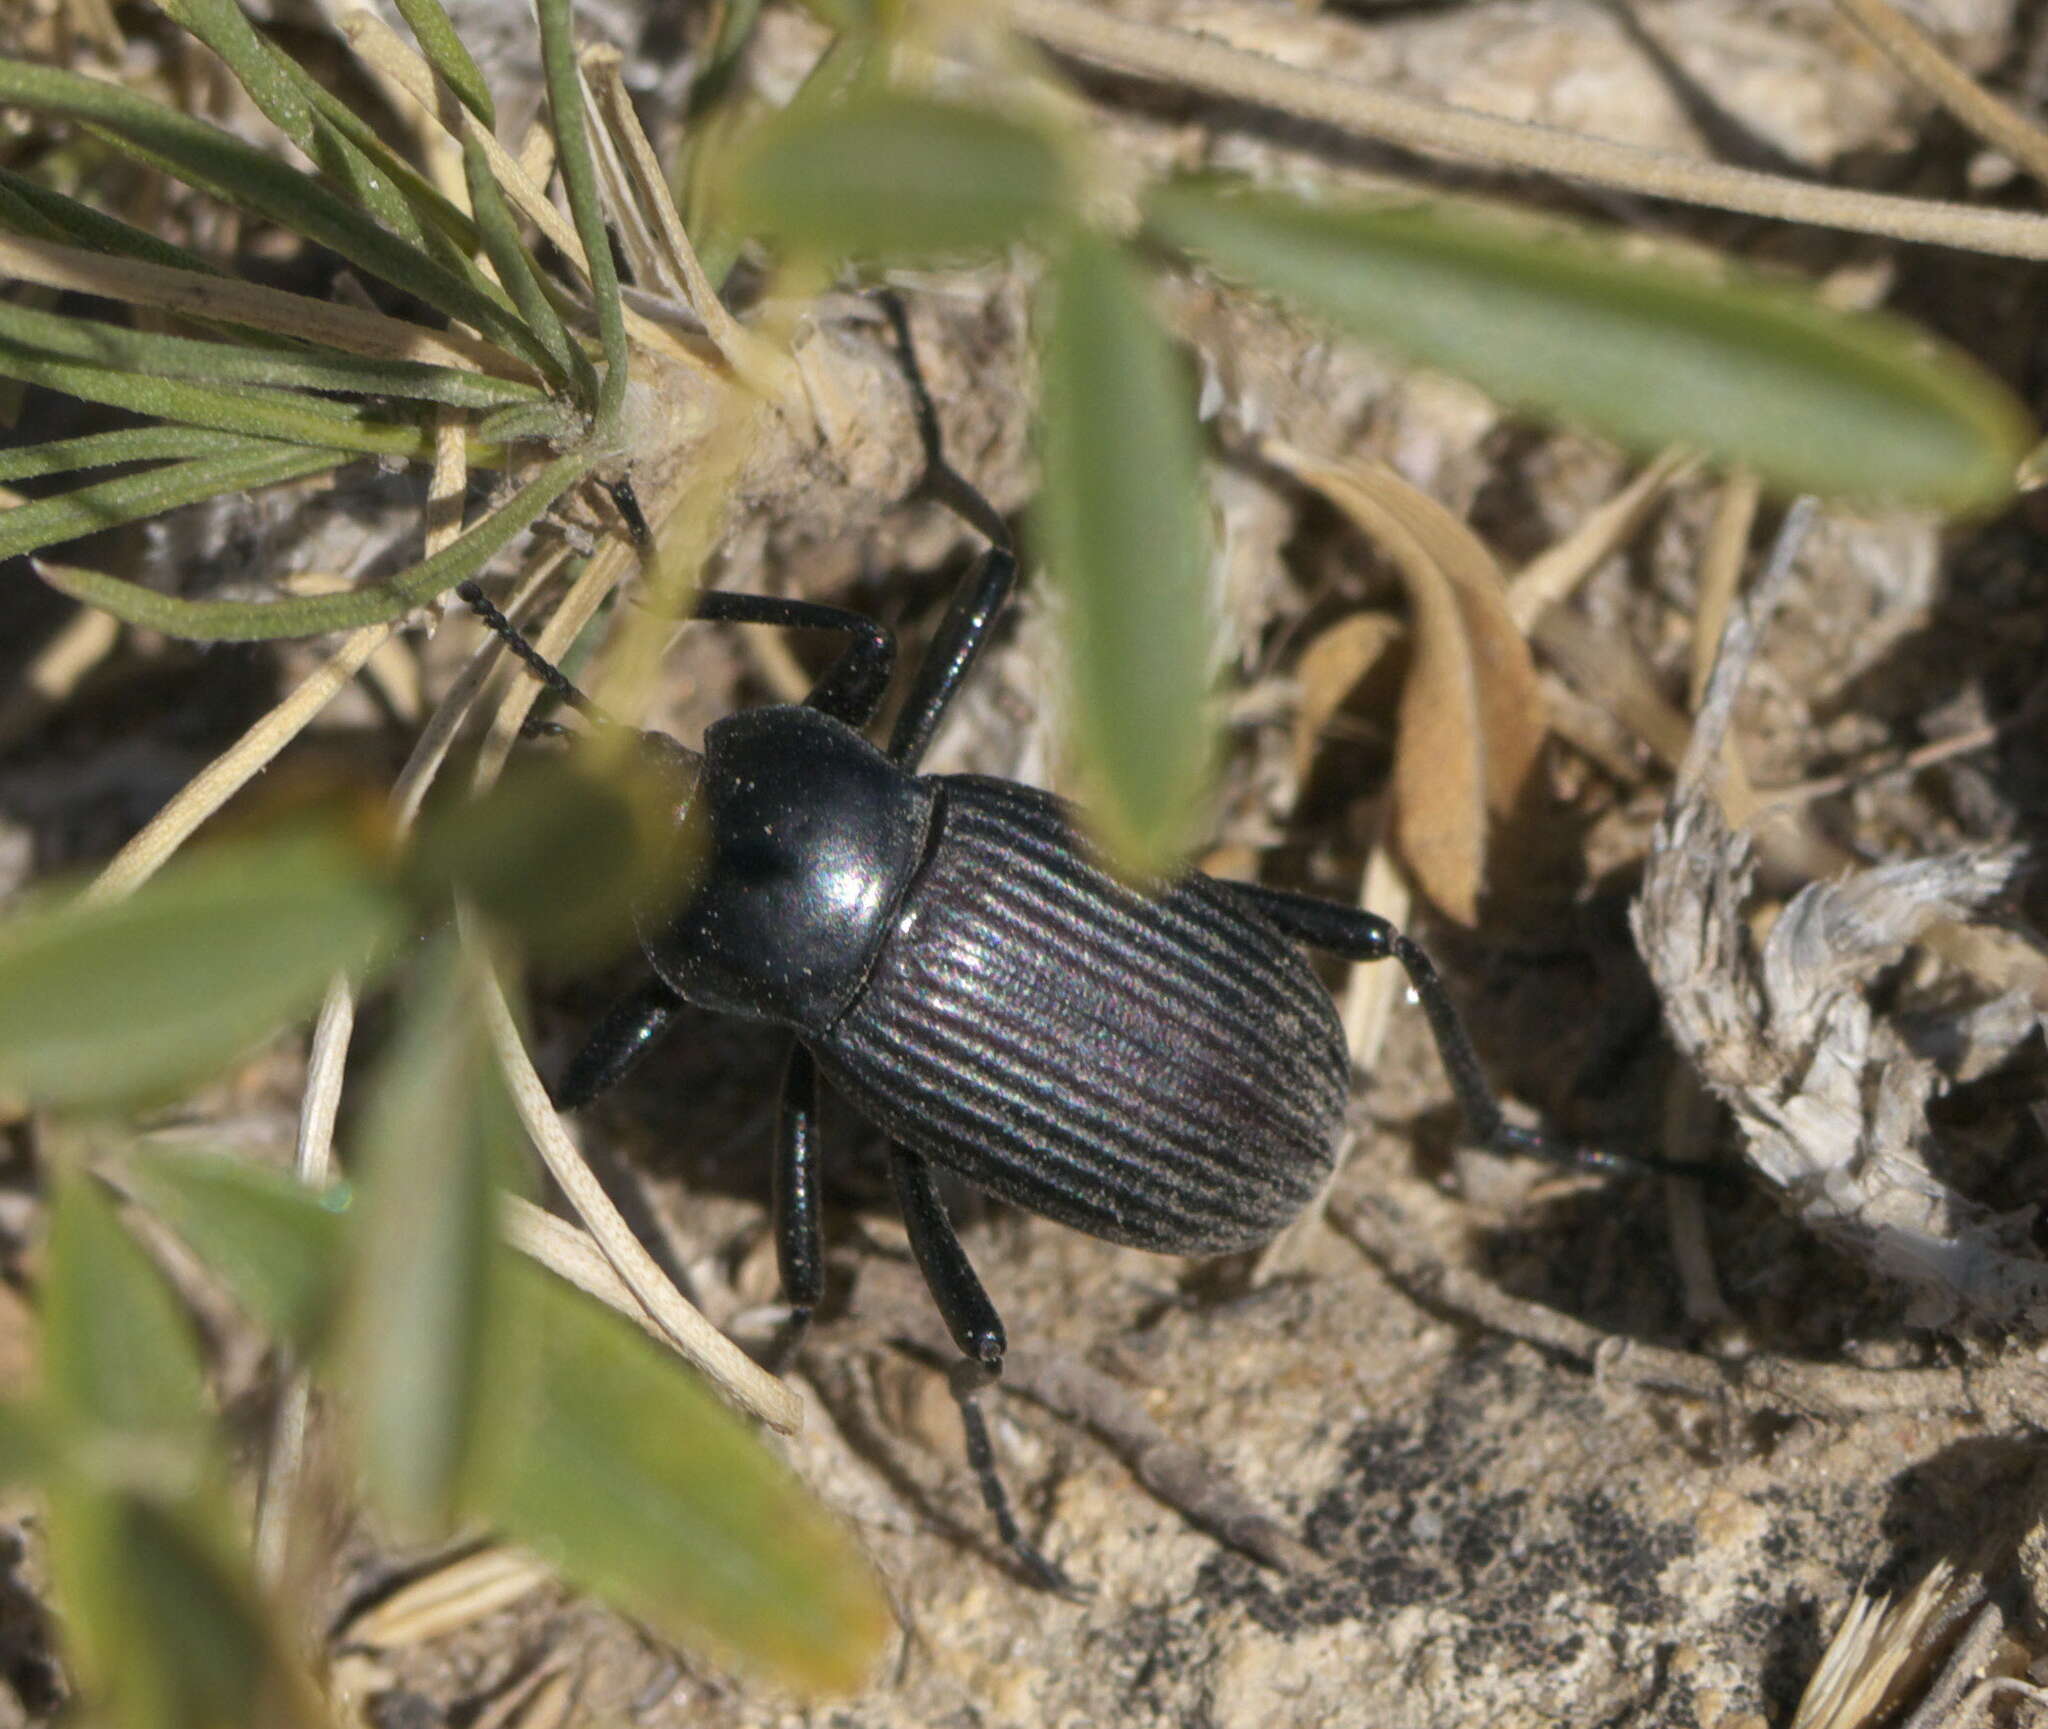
xmin=162 ymin=0 xmax=473 ymax=270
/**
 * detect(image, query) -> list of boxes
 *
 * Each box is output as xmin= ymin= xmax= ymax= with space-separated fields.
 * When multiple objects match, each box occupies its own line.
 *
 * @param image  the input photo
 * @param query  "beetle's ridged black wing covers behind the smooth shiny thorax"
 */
xmin=811 ymin=776 xmax=1350 ymax=1254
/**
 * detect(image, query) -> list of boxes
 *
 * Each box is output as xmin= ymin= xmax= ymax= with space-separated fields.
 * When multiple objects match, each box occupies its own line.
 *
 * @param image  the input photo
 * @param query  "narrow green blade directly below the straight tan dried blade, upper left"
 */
xmin=0 ymin=303 xmax=549 ymax=410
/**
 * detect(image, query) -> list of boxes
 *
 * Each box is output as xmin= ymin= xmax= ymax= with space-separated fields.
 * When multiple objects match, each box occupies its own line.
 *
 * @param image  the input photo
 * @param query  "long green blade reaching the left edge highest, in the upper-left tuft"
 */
xmin=0 ymin=59 xmax=547 ymax=378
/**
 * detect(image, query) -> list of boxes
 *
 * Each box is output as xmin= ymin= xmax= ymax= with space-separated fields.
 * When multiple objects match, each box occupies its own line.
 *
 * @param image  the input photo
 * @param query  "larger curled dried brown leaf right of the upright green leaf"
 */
xmin=1268 ymin=445 xmax=1546 ymax=924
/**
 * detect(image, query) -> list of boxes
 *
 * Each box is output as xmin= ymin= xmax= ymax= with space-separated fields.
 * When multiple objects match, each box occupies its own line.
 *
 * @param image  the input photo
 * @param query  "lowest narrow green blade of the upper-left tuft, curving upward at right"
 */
xmin=41 ymin=451 xmax=590 ymax=643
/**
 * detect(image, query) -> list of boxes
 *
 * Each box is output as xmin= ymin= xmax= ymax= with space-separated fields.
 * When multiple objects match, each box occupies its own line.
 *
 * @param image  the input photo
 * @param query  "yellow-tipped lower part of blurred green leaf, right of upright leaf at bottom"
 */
xmin=471 ymin=1264 xmax=889 ymax=1690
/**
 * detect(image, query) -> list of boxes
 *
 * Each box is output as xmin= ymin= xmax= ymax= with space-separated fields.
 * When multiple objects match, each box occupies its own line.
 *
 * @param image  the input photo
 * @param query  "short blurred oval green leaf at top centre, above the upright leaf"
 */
xmin=733 ymin=88 xmax=1067 ymax=262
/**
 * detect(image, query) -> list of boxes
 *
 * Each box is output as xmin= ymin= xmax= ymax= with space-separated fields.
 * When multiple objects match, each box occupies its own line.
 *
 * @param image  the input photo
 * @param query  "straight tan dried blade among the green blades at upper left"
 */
xmin=0 ymin=234 xmax=526 ymax=377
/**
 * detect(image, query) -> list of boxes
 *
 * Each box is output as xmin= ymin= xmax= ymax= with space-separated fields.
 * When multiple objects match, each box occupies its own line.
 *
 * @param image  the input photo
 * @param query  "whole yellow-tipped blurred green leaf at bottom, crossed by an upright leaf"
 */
xmin=116 ymin=1163 xmax=889 ymax=1688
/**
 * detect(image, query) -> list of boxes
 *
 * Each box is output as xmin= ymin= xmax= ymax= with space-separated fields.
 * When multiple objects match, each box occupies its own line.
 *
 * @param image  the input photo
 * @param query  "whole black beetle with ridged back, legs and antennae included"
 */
xmin=461 ymin=301 xmax=1657 ymax=1590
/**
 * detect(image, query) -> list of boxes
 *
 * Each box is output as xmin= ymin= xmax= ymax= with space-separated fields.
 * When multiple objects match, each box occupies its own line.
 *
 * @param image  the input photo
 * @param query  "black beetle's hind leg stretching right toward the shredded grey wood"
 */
xmin=1225 ymin=883 xmax=1716 ymax=1176
